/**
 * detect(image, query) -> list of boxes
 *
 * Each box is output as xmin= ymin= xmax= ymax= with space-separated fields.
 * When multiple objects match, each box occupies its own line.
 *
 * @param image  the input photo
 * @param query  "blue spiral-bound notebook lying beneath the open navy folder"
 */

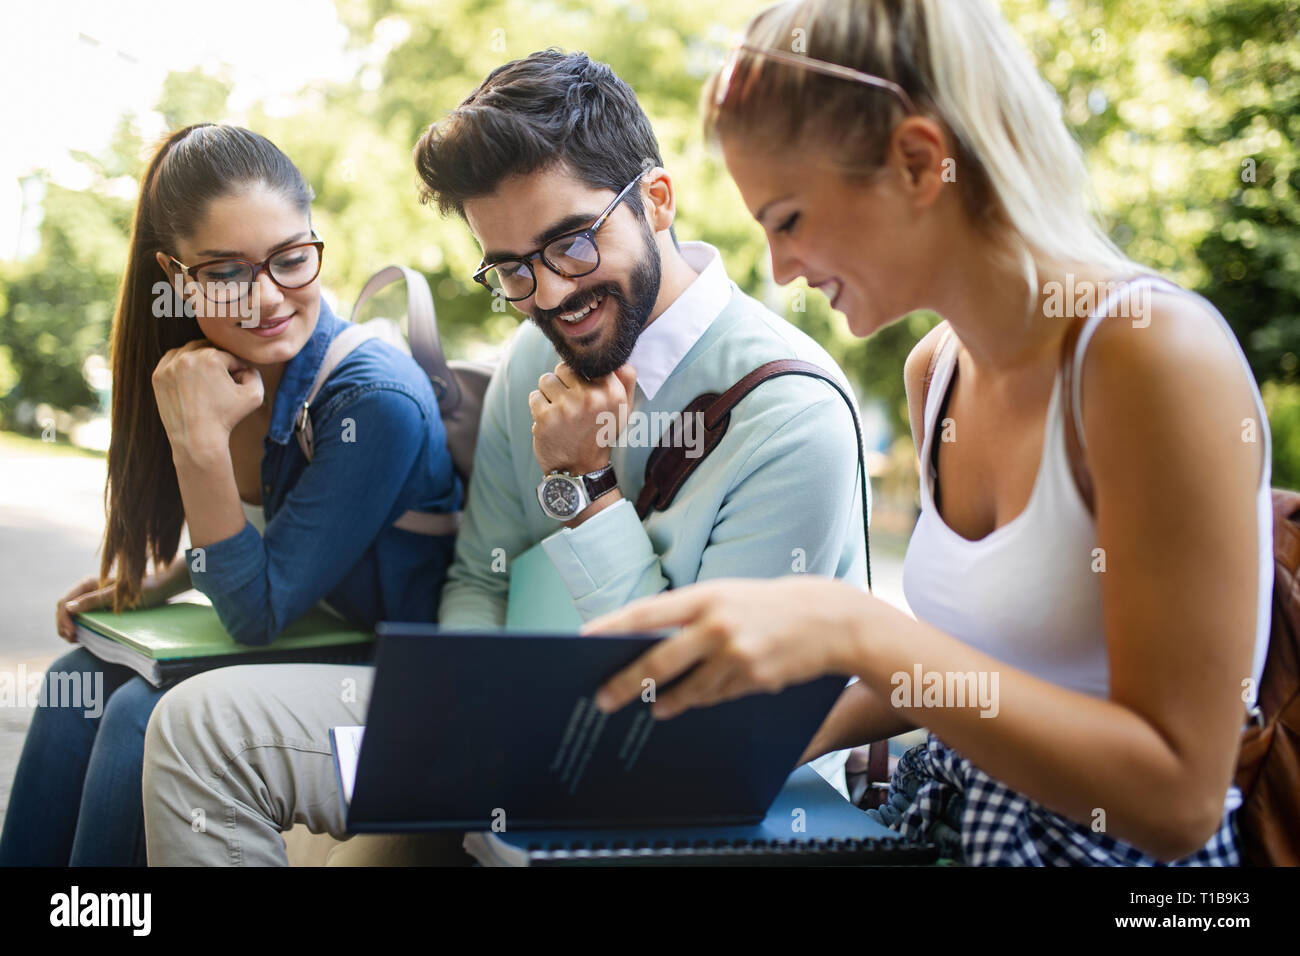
xmin=464 ymin=766 xmax=936 ymax=866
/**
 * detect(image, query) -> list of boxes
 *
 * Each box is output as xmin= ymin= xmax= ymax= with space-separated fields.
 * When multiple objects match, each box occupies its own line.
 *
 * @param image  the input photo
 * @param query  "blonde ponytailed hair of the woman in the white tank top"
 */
xmin=702 ymin=0 xmax=1148 ymax=295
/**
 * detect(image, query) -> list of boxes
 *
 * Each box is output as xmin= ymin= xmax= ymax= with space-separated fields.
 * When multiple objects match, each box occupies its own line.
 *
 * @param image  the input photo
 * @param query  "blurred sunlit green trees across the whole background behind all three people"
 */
xmin=0 ymin=0 xmax=1300 ymax=485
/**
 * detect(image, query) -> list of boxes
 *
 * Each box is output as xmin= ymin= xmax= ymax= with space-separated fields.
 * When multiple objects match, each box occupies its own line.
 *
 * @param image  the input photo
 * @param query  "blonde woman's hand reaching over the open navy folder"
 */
xmin=582 ymin=575 xmax=874 ymax=719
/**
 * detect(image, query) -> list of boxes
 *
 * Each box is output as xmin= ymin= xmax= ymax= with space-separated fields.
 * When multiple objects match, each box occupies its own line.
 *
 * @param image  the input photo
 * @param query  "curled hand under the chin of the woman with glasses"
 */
xmin=153 ymin=339 xmax=264 ymax=459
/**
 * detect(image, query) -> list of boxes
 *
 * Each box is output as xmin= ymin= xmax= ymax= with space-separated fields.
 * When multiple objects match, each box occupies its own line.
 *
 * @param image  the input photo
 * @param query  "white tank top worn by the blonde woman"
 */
xmin=902 ymin=277 xmax=1273 ymax=809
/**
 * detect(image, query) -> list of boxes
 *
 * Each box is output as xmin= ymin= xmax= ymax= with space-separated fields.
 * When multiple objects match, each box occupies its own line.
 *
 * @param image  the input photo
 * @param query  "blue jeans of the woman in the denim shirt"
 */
xmin=0 ymin=648 xmax=165 ymax=866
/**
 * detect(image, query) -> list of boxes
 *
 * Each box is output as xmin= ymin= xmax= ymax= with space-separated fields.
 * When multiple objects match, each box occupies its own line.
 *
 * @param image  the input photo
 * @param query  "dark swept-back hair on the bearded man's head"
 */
xmin=415 ymin=48 xmax=663 ymax=219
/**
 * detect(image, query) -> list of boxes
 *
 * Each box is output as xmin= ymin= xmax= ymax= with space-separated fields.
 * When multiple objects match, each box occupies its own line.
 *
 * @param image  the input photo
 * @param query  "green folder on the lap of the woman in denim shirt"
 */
xmin=77 ymin=601 xmax=374 ymax=687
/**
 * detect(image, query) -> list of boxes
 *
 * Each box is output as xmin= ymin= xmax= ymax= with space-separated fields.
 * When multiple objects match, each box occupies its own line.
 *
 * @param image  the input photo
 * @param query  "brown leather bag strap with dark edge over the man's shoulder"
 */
xmin=637 ymin=359 xmax=871 ymax=591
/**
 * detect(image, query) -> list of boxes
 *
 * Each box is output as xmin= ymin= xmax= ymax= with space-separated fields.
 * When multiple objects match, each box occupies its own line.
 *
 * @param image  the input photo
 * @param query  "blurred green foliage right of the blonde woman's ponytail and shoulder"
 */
xmin=1004 ymin=0 xmax=1300 ymax=486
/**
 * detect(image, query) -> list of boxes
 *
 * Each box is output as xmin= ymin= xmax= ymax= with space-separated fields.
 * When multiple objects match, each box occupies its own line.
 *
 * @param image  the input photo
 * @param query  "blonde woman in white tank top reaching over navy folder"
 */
xmin=588 ymin=0 xmax=1273 ymax=865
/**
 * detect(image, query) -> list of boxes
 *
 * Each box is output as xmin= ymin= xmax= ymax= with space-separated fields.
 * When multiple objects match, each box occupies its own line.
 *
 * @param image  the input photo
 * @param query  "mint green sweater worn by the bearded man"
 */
xmin=439 ymin=282 xmax=866 ymax=630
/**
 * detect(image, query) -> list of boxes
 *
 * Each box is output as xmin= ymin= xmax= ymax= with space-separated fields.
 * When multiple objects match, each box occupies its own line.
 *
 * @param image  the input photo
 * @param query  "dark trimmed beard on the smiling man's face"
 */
xmin=532 ymin=222 xmax=663 ymax=381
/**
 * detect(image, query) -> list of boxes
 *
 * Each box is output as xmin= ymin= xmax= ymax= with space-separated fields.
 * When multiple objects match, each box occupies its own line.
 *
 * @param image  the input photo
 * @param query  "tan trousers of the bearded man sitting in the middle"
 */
xmin=144 ymin=665 xmax=469 ymax=866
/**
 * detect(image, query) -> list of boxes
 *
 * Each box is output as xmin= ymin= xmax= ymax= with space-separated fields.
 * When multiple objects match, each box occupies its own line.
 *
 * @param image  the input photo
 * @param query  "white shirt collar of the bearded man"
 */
xmin=628 ymin=242 xmax=732 ymax=399
